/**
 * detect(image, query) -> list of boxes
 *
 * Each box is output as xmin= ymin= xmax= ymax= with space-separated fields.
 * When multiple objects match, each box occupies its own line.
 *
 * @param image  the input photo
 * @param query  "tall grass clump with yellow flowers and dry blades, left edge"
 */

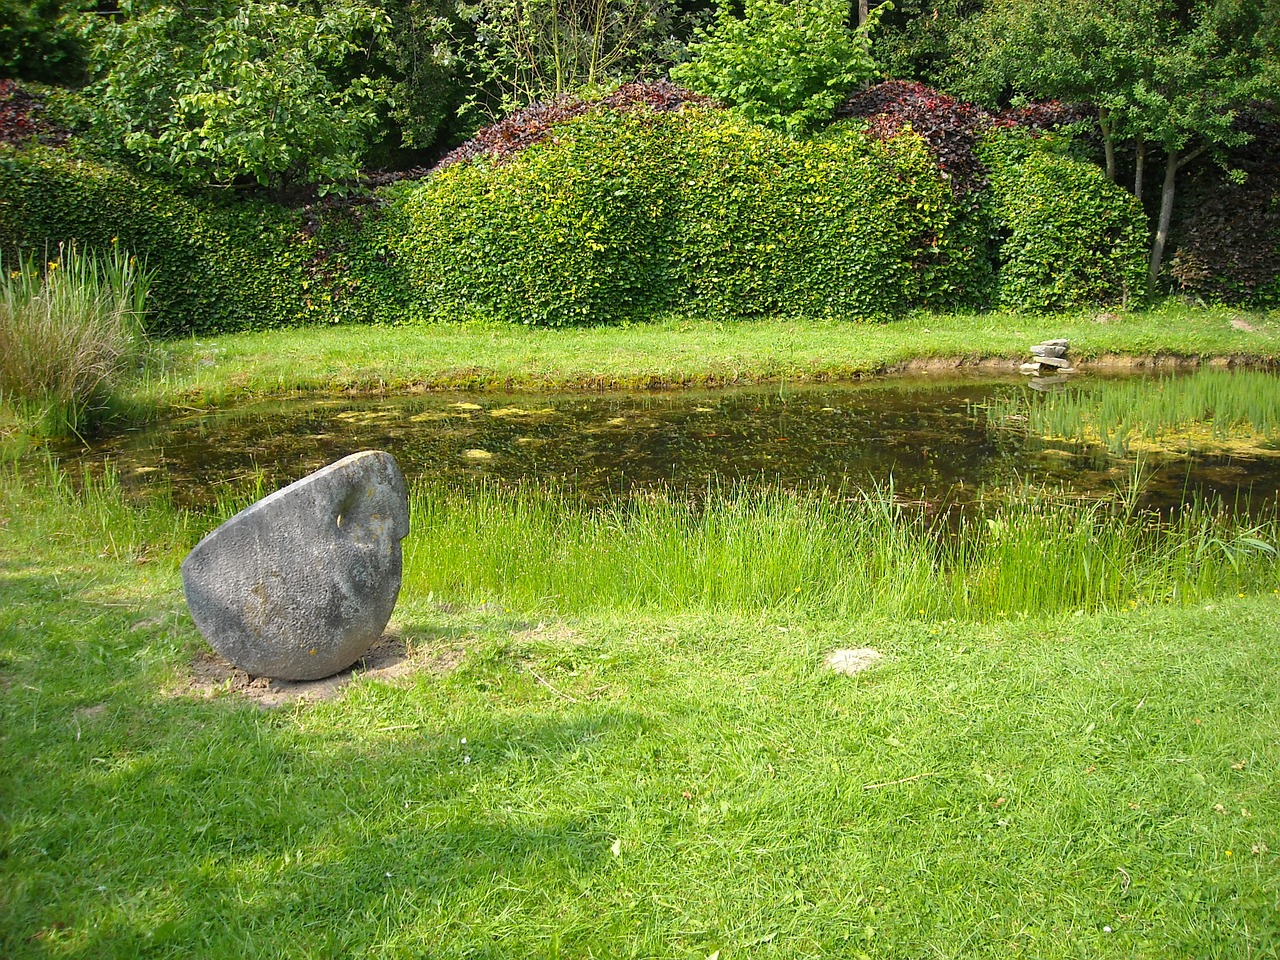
xmin=0 ymin=244 xmax=150 ymax=431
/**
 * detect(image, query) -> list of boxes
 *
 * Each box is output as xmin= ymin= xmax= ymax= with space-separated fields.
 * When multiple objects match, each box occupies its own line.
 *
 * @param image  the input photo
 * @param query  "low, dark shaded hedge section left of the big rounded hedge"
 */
xmin=0 ymin=147 xmax=409 ymax=334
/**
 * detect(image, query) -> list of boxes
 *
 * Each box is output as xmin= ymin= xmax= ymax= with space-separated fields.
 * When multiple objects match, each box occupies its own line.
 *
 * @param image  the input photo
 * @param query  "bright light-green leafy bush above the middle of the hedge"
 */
xmin=671 ymin=0 xmax=893 ymax=133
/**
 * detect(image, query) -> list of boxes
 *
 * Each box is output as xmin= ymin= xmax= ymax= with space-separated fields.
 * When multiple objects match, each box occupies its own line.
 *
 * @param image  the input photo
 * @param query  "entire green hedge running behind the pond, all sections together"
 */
xmin=0 ymin=117 xmax=1146 ymax=334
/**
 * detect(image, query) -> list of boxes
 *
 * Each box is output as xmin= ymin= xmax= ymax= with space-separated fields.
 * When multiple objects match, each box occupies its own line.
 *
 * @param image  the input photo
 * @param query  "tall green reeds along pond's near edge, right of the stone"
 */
xmin=404 ymin=484 xmax=1280 ymax=620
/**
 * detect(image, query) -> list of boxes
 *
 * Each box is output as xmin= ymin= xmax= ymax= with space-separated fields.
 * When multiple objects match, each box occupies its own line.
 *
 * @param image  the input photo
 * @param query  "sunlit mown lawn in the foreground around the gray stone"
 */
xmin=0 ymin=461 xmax=1280 ymax=960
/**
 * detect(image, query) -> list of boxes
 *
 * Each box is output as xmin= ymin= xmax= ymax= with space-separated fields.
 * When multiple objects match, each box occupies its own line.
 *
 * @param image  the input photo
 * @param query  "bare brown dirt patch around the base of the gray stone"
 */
xmin=169 ymin=634 xmax=466 ymax=709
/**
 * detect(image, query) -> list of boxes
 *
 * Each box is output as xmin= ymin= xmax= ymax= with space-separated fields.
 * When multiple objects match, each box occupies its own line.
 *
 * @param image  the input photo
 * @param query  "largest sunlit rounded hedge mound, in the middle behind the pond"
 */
xmin=394 ymin=109 xmax=986 ymax=325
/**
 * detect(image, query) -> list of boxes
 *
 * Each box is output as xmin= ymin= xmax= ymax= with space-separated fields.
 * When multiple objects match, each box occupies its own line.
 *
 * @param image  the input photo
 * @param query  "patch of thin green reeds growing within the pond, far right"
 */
xmin=983 ymin=370 xmax=1280 ymax=454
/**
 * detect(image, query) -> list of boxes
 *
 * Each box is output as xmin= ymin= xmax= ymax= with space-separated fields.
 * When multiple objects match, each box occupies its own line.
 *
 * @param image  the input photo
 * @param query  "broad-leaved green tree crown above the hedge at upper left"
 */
xmin=81 ymin=0 xmax=387 ymax=193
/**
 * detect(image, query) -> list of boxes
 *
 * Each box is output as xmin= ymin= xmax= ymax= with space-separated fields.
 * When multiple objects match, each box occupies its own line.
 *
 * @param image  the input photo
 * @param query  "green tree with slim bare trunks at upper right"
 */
xmin=952 ymin=0 xmax=1280 ymax=291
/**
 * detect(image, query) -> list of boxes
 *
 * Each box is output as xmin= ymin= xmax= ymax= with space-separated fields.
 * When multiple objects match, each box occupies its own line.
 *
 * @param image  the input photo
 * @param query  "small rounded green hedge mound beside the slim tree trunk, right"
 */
xmin=979 ymin=133 xmax=1147 ymax=310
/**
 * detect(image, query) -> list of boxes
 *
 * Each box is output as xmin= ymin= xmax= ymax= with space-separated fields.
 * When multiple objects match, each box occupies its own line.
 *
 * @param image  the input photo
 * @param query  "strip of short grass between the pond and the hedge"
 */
xmin=137 ymin=303 xmax=1280 ymax=406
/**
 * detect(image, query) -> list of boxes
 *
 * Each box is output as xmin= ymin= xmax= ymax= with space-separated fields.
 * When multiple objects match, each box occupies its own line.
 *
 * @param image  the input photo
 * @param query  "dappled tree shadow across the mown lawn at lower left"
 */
xmin=0 ymin=650 xmax=636 ymax=957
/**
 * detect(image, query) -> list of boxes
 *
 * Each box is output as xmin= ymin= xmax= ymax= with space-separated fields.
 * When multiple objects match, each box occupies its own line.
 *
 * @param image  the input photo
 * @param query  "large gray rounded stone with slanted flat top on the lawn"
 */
xmin=182 ymin=451 xmax=408 ymax=680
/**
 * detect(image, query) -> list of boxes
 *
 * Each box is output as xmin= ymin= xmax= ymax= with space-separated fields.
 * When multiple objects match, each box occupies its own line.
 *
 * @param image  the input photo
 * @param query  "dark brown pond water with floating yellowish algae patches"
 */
xmin=61 ymin=374 xmax=1280 ymax=507
